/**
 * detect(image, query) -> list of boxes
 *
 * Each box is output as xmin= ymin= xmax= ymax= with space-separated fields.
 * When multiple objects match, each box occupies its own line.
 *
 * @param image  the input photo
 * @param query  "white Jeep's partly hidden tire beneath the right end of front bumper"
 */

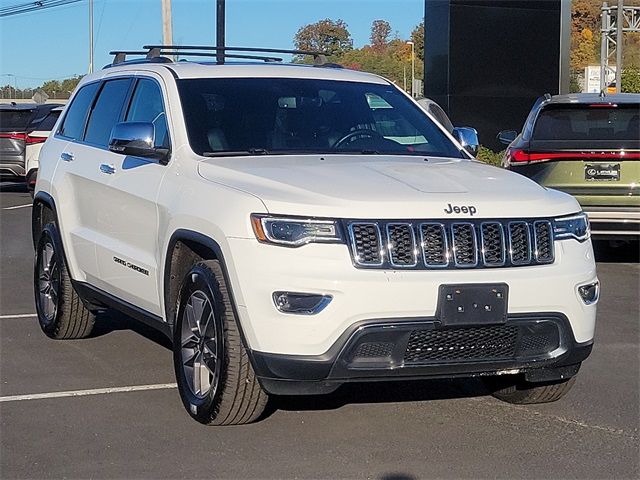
xmin=484 ymin=375 xmax=576 ymax=405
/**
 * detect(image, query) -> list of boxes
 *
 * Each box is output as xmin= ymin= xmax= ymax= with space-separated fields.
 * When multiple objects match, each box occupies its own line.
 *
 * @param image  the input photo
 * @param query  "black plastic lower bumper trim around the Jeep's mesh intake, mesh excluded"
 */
xmin=251 ymin=312 xmax=593 ymax=395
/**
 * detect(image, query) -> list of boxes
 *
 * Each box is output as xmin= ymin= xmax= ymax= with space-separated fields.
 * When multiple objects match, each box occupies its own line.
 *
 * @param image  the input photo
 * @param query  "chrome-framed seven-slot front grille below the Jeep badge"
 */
xmin=346 ymin=219 xmax=554 ymax=269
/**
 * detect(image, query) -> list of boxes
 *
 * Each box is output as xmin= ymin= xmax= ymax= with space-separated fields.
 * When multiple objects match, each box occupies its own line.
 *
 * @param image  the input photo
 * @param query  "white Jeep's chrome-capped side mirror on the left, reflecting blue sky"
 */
xmin=109 ymin=122 xmax=169 ymax=165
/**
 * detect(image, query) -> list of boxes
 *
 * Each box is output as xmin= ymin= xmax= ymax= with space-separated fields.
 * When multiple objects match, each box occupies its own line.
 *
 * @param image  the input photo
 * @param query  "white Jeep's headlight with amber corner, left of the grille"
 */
xmin=251 ymin=214 xmax=343 ymax=247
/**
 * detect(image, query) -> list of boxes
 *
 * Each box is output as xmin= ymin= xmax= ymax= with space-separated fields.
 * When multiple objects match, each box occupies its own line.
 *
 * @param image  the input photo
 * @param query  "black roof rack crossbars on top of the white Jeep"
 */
xmin=105 ymin=45 xmax=332 ymax=68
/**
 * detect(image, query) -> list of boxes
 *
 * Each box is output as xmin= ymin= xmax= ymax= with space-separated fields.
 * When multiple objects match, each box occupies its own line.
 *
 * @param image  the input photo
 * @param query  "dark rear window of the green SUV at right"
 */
xmin=532 ymin=105 xmax=640 ymax=141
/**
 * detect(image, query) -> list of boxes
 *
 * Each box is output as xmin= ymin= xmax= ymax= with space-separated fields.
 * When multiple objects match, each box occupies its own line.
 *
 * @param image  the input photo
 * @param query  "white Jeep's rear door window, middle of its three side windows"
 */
xmin=84 ymin=78 xmax=131 ymax=147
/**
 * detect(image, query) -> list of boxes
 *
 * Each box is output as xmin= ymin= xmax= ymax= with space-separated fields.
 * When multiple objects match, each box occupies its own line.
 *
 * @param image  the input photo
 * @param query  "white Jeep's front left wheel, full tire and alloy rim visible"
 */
xmin=173 ymin=260 xmax=268 ymax=425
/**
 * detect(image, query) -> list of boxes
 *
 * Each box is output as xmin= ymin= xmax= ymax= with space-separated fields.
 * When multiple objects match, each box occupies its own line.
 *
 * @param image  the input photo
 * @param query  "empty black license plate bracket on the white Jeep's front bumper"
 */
xmin=436 ymin=283 xmax=509 ymax=326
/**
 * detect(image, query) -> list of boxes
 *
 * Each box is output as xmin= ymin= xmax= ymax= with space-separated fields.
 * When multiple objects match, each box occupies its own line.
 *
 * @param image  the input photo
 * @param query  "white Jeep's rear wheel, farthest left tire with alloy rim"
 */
xmin=33 ymin=223 xmax=95 ymax=339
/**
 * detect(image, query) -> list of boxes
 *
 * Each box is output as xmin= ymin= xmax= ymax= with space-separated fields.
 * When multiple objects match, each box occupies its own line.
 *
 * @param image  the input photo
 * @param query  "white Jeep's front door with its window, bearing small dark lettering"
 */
xmin=96 ymin=77 xmax=170 ymax=316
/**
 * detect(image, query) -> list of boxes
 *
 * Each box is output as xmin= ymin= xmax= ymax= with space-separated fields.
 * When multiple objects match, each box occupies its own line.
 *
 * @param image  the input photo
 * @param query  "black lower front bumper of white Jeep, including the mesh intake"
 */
xmin=252 ymin=313 xmax=592 ymax=395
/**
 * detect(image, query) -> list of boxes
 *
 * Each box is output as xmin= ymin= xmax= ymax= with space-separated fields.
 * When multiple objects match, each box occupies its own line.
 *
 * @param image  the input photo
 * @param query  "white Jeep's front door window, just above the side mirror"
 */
xmin=126 ymin=78 xmax=169 ymax=148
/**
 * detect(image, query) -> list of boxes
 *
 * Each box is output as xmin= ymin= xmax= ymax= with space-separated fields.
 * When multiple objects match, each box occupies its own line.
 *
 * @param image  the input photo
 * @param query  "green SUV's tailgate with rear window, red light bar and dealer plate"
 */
xmin=529 ymin=103 xmax=640 ymax=206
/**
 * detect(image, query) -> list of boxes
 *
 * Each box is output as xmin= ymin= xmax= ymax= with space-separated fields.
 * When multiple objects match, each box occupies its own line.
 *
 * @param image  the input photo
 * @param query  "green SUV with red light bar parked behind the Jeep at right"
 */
xmin=498 ymin=93 xmax=640 ymax=240
